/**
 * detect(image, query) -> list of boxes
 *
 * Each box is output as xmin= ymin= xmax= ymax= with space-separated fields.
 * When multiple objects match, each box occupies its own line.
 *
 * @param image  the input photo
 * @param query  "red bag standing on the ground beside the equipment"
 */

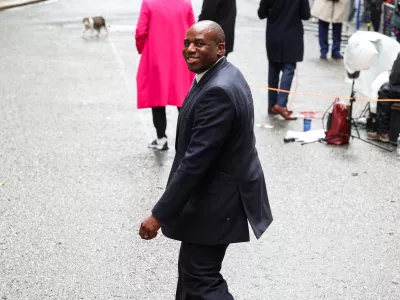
xmin=325 ymin=101 xmax=350 ymax=145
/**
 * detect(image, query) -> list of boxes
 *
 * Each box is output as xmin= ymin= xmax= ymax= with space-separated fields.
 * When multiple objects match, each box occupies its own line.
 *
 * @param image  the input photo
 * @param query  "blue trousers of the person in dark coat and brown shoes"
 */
xmin=268 ymin=61 xmax=296 ymax=108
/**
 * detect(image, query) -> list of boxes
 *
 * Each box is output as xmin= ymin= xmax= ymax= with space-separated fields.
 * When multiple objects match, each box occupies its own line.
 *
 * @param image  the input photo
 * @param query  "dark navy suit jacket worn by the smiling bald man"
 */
xmin=152 ymin=58 xmax=272 ymax=245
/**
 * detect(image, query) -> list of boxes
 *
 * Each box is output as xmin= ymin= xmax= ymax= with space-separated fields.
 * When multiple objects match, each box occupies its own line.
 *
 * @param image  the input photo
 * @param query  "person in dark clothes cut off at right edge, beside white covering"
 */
xmin=368 ymin=53 xmax=400 ymax=143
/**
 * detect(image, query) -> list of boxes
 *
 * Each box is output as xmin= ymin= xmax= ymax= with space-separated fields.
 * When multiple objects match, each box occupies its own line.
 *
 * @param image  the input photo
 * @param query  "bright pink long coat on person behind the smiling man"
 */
xmin=135 ymin=0 xmax=195 ymax=108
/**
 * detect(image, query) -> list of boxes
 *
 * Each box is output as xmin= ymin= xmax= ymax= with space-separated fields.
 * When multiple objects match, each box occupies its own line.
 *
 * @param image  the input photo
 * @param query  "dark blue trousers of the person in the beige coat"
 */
xmin=318 ymin=20 xmax=342 ymax=56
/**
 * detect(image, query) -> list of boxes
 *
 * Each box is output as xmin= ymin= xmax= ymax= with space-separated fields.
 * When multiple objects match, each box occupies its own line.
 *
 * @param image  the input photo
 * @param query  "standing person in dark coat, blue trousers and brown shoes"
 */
xmin=258 ymin=0 xmax=311 ymax=120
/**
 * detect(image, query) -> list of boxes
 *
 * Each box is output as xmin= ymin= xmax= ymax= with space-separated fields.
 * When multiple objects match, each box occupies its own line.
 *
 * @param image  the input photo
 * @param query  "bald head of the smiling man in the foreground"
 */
xmin=183 ymin=21 xmax=225 ymax=74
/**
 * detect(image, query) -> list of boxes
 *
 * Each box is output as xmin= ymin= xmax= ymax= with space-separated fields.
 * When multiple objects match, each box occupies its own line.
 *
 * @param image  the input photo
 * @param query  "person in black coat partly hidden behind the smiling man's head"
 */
xmin=199 ymin=0 xmax=236 ymax=57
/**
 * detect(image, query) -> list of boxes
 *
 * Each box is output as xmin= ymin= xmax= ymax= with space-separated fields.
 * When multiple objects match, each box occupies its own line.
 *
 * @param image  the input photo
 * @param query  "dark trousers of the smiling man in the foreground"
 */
xmin=175 ymin=242 xmax=234 ymax=300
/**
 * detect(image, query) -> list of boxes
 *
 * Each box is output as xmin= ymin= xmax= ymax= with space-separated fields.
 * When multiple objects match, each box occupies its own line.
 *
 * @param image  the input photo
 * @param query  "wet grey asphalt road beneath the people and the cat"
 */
xmin=0 ymin=0 xmax=400 ymax=300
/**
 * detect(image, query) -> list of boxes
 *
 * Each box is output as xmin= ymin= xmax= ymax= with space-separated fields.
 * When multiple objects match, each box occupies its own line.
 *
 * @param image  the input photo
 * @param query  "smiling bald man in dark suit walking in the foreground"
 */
xmin=139 ymin=21 xmax=272 ymax=300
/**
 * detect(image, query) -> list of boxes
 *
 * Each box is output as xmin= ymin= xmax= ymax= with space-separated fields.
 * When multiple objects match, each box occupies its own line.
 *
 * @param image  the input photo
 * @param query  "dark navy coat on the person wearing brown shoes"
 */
xmin=258 ymin=0 xmax=311 ymax=63
